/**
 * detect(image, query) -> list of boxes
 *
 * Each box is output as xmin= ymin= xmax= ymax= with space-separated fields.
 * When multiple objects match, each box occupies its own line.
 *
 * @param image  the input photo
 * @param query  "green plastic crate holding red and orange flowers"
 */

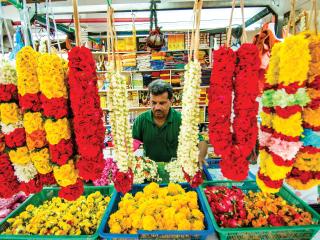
xmin=200 ymin=180 xmax=320 ymax=240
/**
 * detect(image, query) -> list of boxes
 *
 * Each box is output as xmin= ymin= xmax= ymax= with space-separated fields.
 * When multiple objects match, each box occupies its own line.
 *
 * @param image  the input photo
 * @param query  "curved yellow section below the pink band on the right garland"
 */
xmin=260 ymin=150 xmax=292 ymax=181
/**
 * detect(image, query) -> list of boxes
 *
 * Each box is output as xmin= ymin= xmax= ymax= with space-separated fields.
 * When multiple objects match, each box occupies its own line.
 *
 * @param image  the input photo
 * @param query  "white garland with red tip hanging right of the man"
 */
xmin=175 ymin=61 xmax=203 ymax=187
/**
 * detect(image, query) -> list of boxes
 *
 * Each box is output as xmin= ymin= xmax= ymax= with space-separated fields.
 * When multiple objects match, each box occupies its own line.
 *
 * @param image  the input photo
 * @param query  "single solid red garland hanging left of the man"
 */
xmin=68 ymin=47 xmax=105 ymax=180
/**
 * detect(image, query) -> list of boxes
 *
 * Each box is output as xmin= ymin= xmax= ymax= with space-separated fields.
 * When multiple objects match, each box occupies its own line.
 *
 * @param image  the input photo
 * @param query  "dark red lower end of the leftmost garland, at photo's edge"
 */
xmin=0 ymin=153 xmax=20 ymax=198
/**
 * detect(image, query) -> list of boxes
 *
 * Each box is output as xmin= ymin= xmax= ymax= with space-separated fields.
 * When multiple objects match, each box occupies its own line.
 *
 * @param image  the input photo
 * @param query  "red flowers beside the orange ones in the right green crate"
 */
xmin=205 ymin=186 xmax=247 ymax=228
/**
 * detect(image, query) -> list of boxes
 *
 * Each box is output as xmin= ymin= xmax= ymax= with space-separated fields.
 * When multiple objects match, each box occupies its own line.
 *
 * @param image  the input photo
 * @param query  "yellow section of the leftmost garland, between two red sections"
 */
xmin=0 ymin=103 xmax=21 ymax=125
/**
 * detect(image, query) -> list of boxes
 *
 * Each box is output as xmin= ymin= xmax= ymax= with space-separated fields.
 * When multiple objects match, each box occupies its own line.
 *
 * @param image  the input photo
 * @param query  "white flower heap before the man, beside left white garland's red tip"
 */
xmin=132 ymin=157 xmax=162 ymax=183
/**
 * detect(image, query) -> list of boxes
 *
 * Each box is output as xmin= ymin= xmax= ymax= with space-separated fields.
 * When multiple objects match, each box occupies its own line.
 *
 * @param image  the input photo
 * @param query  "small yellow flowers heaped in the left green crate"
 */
xmin=2 ymin=192 xmax=110 ymax=235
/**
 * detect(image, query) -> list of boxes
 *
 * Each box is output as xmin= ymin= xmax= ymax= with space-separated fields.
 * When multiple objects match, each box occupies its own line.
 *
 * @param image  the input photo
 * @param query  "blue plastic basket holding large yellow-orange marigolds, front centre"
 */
xmin=99 ymin=183 xmax=214 ymax=240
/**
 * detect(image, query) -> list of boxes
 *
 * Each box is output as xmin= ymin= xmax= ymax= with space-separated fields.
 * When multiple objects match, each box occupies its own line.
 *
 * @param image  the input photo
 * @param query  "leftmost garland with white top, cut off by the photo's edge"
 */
xmin=0 ymin=62 xmax=20 ymax=198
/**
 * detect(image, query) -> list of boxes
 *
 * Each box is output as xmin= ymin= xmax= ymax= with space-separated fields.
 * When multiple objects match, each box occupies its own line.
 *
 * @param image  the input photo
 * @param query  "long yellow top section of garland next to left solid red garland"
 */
xmin=37 ymin=53 xmax=67 ymax=99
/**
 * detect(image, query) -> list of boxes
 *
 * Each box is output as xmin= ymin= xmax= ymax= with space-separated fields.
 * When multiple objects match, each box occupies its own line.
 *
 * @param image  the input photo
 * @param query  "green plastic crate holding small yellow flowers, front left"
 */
xmin=0 ymin=186 xmax=114 ymax=240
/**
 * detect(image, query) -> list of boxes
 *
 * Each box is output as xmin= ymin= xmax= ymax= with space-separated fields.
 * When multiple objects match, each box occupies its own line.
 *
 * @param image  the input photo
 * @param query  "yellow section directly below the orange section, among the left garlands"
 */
xmin=30 ymin=148 xmax=52 ymax=174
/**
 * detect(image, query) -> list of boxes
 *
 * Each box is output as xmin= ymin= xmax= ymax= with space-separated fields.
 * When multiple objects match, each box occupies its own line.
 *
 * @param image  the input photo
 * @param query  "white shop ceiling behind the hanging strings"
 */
xmin=3 ymin=0 xmax=304 ymax=34
